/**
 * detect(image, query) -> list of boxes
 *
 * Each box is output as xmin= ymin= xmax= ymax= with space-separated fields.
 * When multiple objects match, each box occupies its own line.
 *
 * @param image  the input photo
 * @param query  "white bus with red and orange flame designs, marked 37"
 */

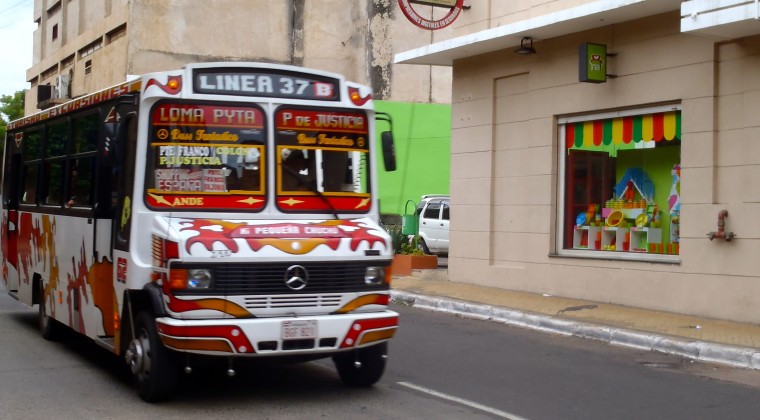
xmin=0 ymin=62 xmax=398 ymax=401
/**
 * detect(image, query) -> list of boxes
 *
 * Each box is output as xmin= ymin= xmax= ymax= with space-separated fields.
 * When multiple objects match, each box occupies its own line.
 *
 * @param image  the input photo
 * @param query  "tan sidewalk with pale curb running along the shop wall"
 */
xmin=391 ymin=269 xmax=760 ymax=369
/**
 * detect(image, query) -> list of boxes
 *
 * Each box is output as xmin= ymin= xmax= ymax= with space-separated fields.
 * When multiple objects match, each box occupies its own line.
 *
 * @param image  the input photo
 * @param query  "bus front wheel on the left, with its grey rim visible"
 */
xmin=125 ymin=312 xmax=179 ymax=402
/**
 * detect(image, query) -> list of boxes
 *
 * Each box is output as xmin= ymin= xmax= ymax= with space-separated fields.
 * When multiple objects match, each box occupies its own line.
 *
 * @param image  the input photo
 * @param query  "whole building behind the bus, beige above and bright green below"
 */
xmin=25 ymin=0 xmax=452 ymax=212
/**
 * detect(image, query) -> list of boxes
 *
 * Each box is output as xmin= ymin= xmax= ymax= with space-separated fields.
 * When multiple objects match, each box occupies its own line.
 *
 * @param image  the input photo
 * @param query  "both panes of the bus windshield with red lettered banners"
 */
xmin=145 ymin=101 xmax=371 ymax=213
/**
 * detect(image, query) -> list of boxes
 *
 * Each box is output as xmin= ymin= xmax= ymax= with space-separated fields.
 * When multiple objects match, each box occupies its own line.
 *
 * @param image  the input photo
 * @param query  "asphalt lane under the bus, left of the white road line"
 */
xmin=0 ymin=288 xmax=492 ymax=420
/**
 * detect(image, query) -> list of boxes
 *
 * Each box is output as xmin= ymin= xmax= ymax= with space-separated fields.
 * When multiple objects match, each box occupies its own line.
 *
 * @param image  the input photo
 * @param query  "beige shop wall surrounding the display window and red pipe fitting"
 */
xmin=449 ymin=13 xmax=760 ymax=322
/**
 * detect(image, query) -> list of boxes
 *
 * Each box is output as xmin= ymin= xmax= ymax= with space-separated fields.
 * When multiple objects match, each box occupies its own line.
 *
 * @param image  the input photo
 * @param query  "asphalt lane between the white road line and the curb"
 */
xmin=386 ymin=308 xmax=760 ymax=419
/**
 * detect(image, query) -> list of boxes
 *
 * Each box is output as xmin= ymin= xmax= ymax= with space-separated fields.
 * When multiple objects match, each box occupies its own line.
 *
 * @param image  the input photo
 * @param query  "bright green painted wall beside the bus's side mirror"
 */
xmin=375 ymin=101 xmax=451 ymax=214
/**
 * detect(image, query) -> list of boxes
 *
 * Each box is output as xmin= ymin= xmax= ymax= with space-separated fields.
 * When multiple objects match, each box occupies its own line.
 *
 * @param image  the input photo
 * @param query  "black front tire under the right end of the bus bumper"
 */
xmin=333 ymin=343 xmax=388 ymax=387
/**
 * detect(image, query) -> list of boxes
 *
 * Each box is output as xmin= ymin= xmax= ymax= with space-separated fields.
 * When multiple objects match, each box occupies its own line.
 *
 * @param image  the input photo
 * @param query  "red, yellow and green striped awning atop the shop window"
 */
xmin=565 ymin=111 xmax=681 ymax=149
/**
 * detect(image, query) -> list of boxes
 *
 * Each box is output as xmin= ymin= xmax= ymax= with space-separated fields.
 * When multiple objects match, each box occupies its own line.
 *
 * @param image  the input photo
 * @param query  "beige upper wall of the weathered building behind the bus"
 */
xmin=26 ymin=0 xmax=453 ymax=114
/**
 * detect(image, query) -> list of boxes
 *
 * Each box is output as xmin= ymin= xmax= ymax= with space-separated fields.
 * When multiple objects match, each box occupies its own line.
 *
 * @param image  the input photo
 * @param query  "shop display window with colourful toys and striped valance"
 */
xmin=559 ymin=107 xmax=681 ymax=256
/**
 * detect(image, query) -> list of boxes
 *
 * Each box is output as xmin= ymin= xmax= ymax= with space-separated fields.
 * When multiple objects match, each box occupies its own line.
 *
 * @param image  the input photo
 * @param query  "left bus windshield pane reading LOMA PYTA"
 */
xmin=146 ymin=102 xmax=266 ymax=211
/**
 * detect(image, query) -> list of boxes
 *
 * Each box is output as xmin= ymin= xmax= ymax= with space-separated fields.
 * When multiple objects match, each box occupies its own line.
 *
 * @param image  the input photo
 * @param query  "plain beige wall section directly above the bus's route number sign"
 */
xmin=127 ymin=0 xmax=290 ymax=74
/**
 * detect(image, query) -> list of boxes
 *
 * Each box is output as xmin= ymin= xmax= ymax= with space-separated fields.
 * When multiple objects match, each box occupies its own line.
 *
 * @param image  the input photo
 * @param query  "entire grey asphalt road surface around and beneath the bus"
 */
xmin=0 ymin=278 xmax=760 ymax=420
